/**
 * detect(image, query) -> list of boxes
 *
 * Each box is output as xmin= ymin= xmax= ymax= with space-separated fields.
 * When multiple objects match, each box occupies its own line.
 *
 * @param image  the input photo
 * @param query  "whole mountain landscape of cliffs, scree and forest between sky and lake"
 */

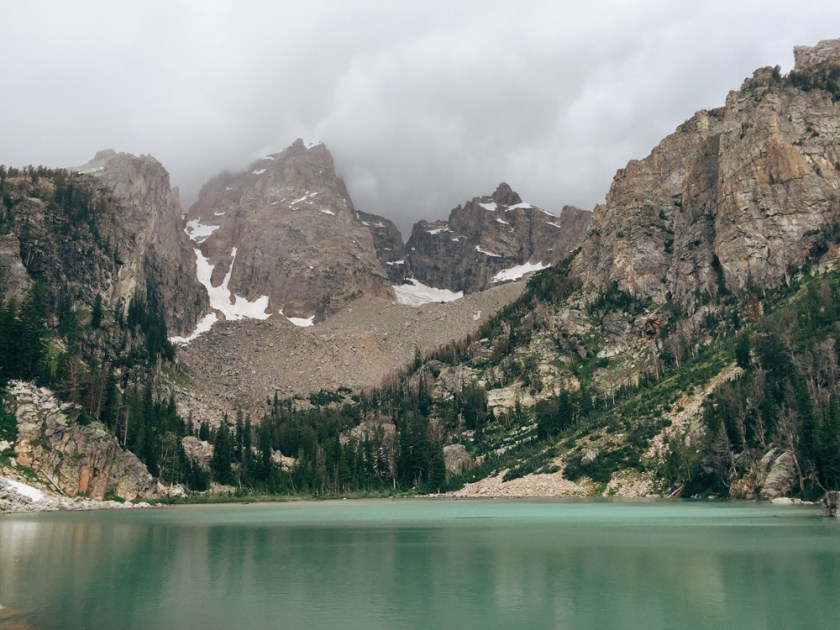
xmin=0 ymin=40 xmax=840 ymax=512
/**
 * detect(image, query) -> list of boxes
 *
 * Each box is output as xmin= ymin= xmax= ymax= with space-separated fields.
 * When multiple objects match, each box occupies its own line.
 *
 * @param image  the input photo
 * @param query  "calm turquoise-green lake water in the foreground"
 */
xmin=0 ymin=500 xmax=840 ymax=630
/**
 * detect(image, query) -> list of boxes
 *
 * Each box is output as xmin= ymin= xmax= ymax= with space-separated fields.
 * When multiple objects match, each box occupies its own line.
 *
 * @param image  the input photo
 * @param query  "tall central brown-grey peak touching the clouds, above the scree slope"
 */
xmin=187 ymin=140 xmax=393 ymax=318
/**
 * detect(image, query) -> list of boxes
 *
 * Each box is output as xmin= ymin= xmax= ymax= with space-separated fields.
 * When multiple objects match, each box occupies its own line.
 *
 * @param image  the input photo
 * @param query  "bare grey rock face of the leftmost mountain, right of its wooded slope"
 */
xmin=73 ymin=150 xmax=208 ymax=333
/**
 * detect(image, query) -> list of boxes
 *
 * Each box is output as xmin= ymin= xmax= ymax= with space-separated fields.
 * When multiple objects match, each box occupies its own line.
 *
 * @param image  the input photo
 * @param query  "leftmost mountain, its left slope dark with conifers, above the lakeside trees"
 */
xmin=0 ymin=150 xmax=207 ymax=332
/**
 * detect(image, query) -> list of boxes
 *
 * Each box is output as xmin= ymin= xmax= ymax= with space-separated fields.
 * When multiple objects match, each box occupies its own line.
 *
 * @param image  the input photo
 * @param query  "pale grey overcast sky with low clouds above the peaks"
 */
xmin=0 ymin=0 xmax=840 ymax=237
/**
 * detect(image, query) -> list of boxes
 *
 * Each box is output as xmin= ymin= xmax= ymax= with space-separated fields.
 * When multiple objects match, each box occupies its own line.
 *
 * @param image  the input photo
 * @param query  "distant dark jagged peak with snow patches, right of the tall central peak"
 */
xmin=406 ymin=183 xmax=591 ymax=293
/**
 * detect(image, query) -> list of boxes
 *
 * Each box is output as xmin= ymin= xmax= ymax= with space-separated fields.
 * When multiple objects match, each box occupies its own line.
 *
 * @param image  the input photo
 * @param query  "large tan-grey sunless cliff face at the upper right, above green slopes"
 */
xmin=573 ymin=41 xmax=840 ymax=305
